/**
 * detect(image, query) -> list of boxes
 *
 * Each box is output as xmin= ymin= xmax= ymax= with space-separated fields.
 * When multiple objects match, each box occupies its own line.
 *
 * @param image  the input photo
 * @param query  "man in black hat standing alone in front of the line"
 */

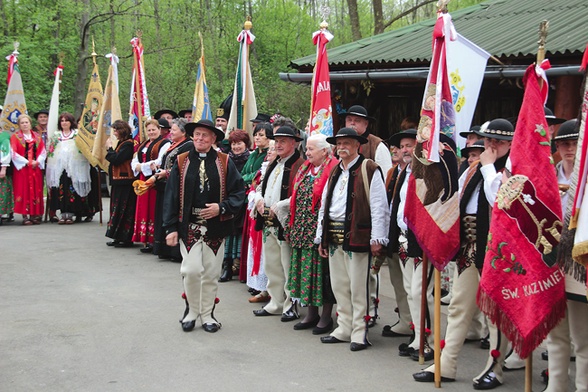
xmin=163 ymin=120 xmax=245 ymax=332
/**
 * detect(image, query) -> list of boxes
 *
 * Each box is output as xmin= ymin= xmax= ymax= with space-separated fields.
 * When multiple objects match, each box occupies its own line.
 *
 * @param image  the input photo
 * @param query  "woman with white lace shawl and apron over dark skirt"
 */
xmin=46 ymin=113 xmax=94 ymax=225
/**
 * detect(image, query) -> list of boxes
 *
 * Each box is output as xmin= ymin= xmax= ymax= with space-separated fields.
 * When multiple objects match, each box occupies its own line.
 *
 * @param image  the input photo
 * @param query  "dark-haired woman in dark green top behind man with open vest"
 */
xmin=239 ymin=122 xmax=273 ymax=283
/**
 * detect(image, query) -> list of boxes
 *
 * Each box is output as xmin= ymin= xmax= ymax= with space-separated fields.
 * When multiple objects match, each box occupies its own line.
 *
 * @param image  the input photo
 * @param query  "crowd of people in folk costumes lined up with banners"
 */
xmin=0 ymin=105 xmax=588 ymax=391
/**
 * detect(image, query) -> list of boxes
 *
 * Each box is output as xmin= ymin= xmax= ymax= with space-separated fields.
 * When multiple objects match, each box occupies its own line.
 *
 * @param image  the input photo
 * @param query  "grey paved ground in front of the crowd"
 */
xmin=0 ymin=199 xmax=568 ymax=392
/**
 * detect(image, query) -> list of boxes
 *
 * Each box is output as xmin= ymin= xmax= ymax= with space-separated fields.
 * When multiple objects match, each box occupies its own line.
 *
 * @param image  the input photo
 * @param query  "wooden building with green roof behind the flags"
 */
xmin=280 ymin=0 xmax=588 ymax=138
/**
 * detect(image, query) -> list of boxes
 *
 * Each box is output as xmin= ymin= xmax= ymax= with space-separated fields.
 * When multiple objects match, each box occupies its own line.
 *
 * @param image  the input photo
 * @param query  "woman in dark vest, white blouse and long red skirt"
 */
xmin=131 ymin=120 xmax=171 ymax=253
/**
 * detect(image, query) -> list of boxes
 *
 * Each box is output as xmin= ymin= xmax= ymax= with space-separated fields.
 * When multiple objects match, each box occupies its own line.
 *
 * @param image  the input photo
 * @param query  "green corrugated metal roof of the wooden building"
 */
xmin=290 ymin=0 xmax=588 ymax=68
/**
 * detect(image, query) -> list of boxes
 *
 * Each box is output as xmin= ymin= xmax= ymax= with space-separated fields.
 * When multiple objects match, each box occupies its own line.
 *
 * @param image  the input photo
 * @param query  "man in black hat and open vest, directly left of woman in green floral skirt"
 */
xmin=253 ymin=126 xmax=303 ymax=322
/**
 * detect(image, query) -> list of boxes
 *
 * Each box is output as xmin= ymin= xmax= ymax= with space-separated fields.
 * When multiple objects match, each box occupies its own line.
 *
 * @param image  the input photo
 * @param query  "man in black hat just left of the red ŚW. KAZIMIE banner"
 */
xmin=413 ymin=118 xmax=514 ymax=390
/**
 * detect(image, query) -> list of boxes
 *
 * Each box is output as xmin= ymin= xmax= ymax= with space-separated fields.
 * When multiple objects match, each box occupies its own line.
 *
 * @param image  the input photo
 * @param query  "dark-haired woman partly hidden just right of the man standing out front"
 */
xmin=218 ymin=129 xmax=251 ymax=282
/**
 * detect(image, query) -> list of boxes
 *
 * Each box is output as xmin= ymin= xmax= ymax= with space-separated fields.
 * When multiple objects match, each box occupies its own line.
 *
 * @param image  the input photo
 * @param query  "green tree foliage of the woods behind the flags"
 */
xmin=0 ymin=0 xmax=479 ymax=127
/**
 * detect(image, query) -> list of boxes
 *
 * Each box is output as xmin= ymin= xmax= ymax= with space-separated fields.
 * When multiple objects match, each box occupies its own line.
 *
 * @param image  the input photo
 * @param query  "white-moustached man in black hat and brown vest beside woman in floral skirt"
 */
xmin=315 ymin=128 xmax=390 ymax=351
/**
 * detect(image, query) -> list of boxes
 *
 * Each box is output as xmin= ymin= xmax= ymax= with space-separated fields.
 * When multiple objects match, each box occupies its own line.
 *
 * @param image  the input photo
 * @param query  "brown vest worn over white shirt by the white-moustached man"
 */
xmin=322 ymin=156 xmax=379 ymax=252
